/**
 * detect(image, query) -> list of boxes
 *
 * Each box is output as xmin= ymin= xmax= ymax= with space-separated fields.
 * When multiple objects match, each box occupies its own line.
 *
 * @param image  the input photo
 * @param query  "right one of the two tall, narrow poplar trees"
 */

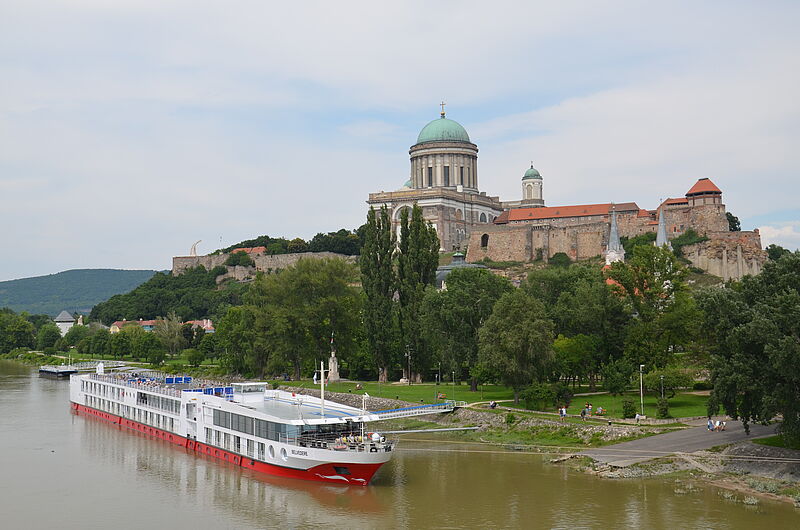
xmin=397 ymin=204 xmax=439 ymax=381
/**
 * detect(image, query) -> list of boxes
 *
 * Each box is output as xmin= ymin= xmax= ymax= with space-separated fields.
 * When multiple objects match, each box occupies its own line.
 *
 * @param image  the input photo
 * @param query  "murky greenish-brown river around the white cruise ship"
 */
xmin=0 ymin=361 xmax=800 ymax=530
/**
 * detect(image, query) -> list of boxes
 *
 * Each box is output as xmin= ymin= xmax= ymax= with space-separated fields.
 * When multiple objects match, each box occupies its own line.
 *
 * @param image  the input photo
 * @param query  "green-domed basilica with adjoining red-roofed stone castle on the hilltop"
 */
xmin=367 ymin=106 xmax=766 ymax=280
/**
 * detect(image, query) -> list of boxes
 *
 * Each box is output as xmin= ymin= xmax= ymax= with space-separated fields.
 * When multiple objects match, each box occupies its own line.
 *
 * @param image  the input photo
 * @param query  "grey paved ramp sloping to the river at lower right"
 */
xmin=580 ymin=421 xmax=775 ymax=467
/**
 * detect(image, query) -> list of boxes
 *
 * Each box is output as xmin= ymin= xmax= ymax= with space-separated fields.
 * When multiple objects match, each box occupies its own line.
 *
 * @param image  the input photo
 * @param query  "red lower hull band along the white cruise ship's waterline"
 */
xmin=72 ymin=403 xmax=383 ymax=486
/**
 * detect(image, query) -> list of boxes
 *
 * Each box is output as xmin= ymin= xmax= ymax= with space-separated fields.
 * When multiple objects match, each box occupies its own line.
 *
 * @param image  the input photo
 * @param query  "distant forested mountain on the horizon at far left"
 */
xmin=0 ymin=269 xmax=156 ymax=316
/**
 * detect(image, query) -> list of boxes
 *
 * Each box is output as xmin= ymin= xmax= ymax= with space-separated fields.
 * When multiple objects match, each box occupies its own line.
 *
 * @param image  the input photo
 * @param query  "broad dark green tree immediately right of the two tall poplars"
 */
xmin=422 ymin=268 xmax=513 ymax=391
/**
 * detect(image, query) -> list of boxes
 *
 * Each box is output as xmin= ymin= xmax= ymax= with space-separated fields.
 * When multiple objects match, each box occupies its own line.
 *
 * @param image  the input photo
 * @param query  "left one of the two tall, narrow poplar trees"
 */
xmin=358 ymin=206 xmax=397 ymax=383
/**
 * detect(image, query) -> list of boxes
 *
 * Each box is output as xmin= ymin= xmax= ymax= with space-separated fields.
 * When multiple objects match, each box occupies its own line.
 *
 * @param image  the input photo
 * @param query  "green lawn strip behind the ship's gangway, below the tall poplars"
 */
xmin=275 ymin=380 xmax=514 ymax=403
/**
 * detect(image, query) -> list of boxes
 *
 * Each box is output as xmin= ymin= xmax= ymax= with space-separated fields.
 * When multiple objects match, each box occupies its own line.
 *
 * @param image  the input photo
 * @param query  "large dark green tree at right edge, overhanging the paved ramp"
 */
xmin=699 ymin=252 xmax=800 ymax=444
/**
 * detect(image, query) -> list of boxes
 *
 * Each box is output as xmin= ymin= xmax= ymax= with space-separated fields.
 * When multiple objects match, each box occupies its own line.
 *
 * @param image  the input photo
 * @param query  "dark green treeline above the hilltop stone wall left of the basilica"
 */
xmin=214 ymin=226 xmax=364 ymax=256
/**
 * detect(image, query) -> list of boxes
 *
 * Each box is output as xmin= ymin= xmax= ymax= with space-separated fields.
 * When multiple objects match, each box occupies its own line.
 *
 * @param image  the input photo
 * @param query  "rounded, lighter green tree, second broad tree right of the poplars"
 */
xmin=479 ymin=290 xmax=553 ymax=403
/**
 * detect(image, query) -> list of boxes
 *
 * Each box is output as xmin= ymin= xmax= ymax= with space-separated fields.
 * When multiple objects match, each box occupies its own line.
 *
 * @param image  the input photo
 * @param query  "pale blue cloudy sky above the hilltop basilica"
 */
xmin=0 ymin=0 xmax=800 ymax=280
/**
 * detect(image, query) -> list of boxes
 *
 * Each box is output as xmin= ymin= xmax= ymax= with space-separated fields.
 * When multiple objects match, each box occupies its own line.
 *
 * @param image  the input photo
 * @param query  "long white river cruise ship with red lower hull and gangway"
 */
xmin=70 ymin=365 xmax=458 ymax=486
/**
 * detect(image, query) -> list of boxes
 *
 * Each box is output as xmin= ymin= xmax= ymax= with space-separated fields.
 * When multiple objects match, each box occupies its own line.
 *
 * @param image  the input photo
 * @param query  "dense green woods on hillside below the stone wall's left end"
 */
xmin=89 ymin=266 xmax=247 ymax=325
